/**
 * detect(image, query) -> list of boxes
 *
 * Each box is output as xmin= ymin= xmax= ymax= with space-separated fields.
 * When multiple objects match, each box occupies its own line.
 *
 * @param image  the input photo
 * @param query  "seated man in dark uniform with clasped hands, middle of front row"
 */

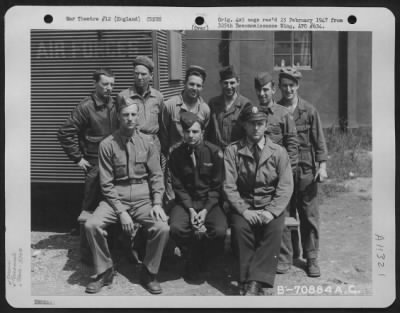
xmin=169 ymin=112 xmax=228 ymax=281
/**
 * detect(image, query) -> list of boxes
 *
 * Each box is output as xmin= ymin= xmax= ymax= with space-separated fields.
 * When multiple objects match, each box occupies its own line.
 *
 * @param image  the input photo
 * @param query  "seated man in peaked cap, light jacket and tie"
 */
xmin=223 ymin=105 xmax=293 ymax=296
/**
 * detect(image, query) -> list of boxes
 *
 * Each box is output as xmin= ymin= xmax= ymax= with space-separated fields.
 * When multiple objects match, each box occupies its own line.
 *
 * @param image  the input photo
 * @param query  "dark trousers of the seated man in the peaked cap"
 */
xmin=231 ymin=212 xmax=285 ymax=287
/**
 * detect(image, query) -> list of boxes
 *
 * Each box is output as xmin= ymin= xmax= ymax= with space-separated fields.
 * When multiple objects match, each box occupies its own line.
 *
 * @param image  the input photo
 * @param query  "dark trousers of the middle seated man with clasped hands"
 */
xmin=170 ymin=204 xmax=228 ymax=254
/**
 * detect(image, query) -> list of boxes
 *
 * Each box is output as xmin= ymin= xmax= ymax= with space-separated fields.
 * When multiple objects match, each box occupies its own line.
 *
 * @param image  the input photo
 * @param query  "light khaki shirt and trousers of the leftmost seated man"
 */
xmin=85 ymin=130 xmax=169 ymax=274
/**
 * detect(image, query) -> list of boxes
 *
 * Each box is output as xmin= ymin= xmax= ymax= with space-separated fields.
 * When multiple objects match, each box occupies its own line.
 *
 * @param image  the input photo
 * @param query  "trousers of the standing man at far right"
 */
xmin=279 ymin=164 xmax=319 ymax=263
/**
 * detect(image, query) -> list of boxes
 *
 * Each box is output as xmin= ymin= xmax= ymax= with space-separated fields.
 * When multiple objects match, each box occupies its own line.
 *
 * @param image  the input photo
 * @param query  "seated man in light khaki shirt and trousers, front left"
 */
xmin=85 ymin=97 xmax=169 ymax=294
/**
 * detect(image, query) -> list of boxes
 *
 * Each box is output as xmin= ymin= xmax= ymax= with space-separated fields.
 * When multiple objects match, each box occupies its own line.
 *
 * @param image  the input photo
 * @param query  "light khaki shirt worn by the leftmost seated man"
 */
xmin=99 ymin=130 xmax=164 ymax=212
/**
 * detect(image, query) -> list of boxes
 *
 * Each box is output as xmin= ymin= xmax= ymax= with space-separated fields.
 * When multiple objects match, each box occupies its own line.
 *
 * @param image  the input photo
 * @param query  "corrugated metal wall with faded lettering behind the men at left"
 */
xmin=31 ymin=30 xmax=183 ymax=183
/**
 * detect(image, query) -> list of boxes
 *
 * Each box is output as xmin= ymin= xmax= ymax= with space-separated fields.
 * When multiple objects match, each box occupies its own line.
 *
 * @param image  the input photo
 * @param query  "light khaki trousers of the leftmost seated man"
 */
xmin=85 ymin=183 xmax=169 ymax=274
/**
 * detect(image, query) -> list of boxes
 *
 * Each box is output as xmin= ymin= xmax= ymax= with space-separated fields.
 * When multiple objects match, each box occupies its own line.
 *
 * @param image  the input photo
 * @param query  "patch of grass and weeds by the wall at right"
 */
xmin=325 ymin=127 xmax=372 ymax=181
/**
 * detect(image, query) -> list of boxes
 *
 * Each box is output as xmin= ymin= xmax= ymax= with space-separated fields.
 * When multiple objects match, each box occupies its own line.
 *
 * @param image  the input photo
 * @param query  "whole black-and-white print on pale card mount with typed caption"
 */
xmin=6 ymin=8 xmax=395 ymax=307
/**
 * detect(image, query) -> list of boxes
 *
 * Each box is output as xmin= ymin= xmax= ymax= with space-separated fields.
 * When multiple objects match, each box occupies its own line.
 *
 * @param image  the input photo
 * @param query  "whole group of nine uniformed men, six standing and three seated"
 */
xmin=58 ymin=56 xmax=327 ymax=296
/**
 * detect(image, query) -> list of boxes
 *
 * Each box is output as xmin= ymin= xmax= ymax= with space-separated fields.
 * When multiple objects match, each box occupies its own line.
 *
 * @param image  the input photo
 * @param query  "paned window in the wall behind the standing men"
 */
xmin=274 ymin=31 xmax=312 ymax=69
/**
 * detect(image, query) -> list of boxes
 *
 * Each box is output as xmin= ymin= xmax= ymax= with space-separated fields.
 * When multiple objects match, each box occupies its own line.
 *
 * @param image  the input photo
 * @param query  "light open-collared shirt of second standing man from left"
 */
xmin=117 ymin=86 xmax=164 ymax=135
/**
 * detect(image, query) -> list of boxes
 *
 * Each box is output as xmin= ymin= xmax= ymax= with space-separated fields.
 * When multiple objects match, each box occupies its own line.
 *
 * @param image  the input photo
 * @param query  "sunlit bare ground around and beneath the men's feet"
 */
xmin=31 ymin=178 xmax=372 ymax=297
